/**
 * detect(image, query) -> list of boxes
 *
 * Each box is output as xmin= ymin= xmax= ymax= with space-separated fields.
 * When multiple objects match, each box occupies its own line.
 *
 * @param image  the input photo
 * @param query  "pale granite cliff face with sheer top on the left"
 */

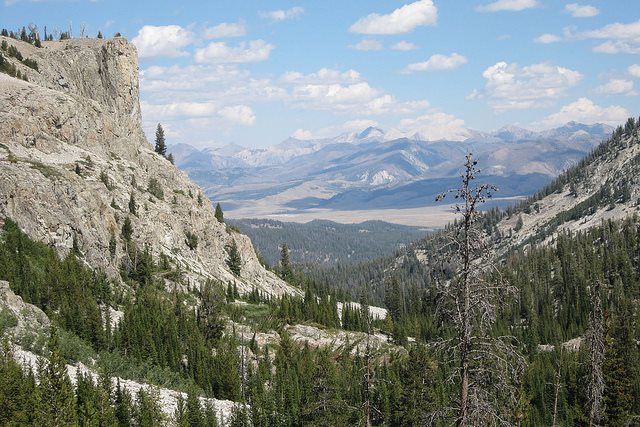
xmin=0 ymin=37 xmax=297 ymax=294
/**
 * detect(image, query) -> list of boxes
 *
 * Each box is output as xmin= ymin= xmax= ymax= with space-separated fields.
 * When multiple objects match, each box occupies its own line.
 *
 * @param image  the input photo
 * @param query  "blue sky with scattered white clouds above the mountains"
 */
xmin=0 ymin=0 xmax=640 ymax=148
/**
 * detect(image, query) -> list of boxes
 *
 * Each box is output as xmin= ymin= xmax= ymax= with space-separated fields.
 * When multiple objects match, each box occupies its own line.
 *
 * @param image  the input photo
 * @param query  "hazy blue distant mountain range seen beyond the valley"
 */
xmin=169 ymin=122 xmax=613 ymax=220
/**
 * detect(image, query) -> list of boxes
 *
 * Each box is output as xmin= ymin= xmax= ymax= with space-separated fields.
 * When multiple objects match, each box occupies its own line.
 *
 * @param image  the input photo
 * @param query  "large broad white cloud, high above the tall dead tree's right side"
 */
xmin=482 ymin=62 xmax=582 ymax=110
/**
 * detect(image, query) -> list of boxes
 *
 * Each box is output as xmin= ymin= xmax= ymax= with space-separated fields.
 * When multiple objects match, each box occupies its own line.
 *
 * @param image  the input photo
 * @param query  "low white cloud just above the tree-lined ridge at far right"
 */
xmin=534 ymin=98 xmax=630 ymax=128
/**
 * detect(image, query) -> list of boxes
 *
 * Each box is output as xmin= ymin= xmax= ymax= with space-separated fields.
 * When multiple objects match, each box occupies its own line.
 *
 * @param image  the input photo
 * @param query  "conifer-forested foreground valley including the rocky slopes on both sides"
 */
xmin=0 ymin=23 xmax=640 ymax=427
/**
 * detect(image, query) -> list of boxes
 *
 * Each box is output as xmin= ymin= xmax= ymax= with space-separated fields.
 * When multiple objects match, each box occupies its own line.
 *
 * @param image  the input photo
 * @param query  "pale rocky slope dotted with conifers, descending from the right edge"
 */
xmin=498 ymin=118 xmax=640 ymax=244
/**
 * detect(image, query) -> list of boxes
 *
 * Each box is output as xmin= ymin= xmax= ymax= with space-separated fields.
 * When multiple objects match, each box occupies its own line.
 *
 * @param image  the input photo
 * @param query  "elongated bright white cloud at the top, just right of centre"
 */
xmin=349 ymin=0 xmax=438 ymax=35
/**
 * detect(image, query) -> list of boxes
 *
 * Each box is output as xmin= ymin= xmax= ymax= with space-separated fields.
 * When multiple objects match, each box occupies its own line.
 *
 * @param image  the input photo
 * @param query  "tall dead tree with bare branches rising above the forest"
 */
xmin=434 ymin=153 xmax=525 ymax=426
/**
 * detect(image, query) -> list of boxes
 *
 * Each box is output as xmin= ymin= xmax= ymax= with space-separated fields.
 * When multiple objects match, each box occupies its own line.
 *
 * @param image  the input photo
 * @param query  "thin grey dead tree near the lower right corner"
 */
xmin=587 ymin=280 xmax=605 ymax=427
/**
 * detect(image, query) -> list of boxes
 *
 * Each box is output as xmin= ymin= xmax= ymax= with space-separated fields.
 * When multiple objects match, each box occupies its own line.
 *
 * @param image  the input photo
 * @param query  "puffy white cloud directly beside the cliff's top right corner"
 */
xmin=131 ymin=25 xmax=195 ymax=58
